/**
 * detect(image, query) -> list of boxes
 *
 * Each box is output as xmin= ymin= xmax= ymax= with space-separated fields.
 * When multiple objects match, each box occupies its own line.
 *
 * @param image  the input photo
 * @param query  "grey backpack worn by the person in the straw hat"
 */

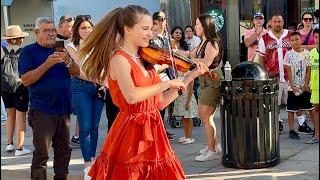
xmin=1 ymin=46 xmax=22 ymax=93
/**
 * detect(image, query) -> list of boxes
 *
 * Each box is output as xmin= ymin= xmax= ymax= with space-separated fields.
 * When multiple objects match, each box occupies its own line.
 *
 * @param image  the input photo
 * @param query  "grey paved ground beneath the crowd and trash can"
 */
xmin=1 ymin=107 xmax=319 ymax=180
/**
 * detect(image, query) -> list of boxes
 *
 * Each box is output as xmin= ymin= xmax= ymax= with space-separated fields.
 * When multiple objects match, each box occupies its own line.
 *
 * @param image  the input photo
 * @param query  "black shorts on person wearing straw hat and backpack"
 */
xmin=1 ymin=85 xmax=29 ymax=112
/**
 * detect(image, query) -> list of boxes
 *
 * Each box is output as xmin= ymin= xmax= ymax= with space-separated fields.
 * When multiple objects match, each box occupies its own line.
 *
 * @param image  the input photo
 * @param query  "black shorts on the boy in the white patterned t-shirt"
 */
xmin=287 ymin=91 xmax=314 ymax=112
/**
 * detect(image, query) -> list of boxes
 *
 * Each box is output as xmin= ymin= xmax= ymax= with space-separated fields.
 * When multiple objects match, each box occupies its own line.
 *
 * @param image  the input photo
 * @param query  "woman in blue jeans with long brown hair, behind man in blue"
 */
xmin=66 ymin=15 xmax=104 ymax=172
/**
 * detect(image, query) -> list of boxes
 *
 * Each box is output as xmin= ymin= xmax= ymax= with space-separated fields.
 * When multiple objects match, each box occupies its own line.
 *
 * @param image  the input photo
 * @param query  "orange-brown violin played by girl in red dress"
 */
xmin=139 ymin=47 xmax=196 ymax=72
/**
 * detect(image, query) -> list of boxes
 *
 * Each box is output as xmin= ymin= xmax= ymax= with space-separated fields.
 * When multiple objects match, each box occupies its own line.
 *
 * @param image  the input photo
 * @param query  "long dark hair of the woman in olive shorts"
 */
xmin=199 ymin=14 xmax=223 ymax=69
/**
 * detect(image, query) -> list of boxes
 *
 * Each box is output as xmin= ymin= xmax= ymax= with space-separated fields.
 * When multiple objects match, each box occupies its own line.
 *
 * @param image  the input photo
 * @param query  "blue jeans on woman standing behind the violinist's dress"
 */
xmin=71 ymin=77 xmax=104 ymax=162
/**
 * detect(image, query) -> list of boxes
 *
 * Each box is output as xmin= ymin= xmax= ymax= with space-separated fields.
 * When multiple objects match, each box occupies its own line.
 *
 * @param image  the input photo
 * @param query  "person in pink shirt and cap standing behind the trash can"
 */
xmin=244 ymin=12 xmax=268 ymax=61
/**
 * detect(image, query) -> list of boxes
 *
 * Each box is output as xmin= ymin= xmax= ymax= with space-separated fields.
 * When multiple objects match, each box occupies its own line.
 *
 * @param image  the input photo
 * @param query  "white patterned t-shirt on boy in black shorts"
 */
xmin=284 ymin=49 xmax=311 ymax=91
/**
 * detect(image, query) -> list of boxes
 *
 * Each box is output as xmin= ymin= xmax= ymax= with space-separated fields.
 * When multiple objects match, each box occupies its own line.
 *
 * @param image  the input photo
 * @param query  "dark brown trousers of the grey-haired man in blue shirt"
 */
xmin=28 ymin=109 xmax=71 ymax=180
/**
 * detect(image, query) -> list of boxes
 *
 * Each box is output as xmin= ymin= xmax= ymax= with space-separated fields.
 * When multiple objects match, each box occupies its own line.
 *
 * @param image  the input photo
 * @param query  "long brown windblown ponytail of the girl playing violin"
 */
xmin=79 ymin=5 xmax=150 ymax=80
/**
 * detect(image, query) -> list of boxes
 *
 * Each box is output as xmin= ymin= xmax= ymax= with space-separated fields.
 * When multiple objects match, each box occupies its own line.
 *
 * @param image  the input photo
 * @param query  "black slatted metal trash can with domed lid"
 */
xmin=220 ymin=62 xmax=280 ymax=169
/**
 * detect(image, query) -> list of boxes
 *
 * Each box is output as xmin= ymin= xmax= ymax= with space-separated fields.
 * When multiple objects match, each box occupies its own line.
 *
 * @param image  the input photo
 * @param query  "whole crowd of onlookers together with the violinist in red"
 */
xmin=1 ymin=5 xmax=319 ymax=179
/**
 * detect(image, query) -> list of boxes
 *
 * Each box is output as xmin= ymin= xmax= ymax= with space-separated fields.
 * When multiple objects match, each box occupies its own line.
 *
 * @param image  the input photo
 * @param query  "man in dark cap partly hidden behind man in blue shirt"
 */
xmin=57 ymin=15 xmax=75 ymax=44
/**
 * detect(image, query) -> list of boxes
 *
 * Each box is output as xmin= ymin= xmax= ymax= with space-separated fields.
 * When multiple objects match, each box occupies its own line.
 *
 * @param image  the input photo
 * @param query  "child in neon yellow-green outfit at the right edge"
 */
xmin=306 ymin=29 xmax=319 ymax=144
